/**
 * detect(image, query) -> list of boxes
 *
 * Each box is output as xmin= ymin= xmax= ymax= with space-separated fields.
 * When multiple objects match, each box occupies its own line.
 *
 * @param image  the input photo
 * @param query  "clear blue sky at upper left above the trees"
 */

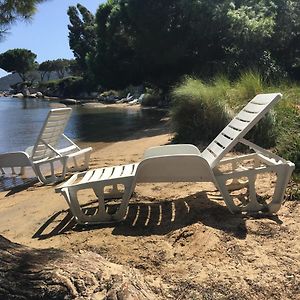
xmin=0 ymin=0 xmax=105 ymax=77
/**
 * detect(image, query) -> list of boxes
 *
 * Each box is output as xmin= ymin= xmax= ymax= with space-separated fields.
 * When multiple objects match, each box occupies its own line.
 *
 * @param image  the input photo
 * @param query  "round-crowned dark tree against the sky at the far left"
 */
xmin=0 ymin=48 xmax=36 ymax=81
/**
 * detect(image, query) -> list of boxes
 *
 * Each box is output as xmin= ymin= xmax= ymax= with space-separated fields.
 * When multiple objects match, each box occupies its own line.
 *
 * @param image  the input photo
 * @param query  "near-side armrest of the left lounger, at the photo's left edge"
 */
xmin=0 ymin=151 xmax=32 ymax=168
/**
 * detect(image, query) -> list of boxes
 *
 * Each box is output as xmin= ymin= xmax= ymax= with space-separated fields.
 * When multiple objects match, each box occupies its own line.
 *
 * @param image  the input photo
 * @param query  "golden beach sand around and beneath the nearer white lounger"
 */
xmin=0 ymin=123 xmax=300 ymax=299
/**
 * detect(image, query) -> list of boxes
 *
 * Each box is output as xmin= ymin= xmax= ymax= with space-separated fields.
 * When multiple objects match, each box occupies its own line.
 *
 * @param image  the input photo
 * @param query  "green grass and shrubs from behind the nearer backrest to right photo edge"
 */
xmin=171 ymin=71 xmax=300 ymax=177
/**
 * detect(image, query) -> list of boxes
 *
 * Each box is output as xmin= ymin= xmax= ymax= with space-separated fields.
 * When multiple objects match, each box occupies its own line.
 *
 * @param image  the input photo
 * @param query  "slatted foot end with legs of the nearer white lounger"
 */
xmin=55 ymin=164 xmax=138 ymax=224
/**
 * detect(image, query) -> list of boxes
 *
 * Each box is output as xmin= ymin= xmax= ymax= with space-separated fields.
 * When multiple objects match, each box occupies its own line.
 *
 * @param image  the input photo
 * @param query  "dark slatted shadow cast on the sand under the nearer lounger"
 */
xmin=33 ymin=192 xmax=264 ymax=239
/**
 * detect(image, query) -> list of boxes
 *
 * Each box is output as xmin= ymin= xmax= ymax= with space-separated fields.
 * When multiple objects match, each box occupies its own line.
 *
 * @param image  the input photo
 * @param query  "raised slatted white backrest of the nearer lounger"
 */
xmin=201 ymin=93 xmax=282 ymax=168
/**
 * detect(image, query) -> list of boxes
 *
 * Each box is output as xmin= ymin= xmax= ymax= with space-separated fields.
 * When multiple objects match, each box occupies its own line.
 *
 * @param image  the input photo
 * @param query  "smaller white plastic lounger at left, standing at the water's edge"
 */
xmin=0 ymin=108 xmax=92 ymax=184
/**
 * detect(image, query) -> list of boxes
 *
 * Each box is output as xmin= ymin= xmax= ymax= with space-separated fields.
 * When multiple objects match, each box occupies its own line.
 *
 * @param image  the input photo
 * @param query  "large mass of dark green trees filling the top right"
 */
xmin=69 ymin=0 xmax=300 ymax=89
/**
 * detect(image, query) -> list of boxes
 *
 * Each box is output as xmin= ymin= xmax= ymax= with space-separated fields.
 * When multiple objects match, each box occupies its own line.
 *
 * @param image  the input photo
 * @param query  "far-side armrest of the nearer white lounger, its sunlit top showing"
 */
xmin=143 ymin=144 xmax=201 ymax=159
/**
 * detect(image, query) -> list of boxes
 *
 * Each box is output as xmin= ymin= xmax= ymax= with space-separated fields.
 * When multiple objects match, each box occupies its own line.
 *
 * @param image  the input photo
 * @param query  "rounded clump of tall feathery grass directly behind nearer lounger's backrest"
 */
xmin=172 ymin=71 xmax=276 ymax=147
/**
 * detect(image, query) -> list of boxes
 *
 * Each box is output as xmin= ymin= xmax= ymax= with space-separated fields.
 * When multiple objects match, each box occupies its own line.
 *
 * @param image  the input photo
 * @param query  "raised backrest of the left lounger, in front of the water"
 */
xmin=31 ymin=108 xmax=72 ymax=161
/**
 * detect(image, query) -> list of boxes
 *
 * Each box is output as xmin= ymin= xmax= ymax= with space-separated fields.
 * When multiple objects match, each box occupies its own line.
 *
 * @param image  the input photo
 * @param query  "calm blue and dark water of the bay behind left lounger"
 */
xmin=0 ymin=98 xmax=165 ymax=153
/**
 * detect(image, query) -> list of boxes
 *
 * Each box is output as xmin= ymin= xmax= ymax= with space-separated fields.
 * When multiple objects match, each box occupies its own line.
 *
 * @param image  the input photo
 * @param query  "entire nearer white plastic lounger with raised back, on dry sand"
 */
xmin=56 ymin=94 xmax=294 ymax=224
